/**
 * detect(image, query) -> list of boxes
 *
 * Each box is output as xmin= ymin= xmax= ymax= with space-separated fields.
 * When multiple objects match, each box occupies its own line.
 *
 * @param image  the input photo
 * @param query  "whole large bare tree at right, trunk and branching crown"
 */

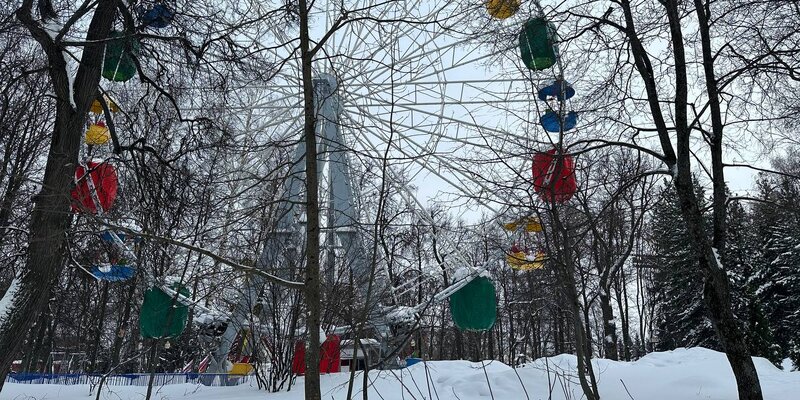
xmin=567 ymin=0 xmax=798 ymax=399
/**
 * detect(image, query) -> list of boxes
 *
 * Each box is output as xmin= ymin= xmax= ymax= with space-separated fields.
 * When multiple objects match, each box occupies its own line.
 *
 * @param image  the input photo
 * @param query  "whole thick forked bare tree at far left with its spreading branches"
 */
xmin=0 ymin=0 xmax=296 ymax=388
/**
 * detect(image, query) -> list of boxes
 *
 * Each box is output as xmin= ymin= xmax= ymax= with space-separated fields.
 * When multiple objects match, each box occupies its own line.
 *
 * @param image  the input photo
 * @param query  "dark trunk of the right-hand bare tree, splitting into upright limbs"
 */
xmin=621 ymin=0 xmax=763 ymax=400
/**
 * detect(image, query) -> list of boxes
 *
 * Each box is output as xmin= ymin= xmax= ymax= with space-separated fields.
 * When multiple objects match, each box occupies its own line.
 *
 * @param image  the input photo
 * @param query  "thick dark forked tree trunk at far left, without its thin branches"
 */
xmin=0 ymin=0 xmax=117 ymax=388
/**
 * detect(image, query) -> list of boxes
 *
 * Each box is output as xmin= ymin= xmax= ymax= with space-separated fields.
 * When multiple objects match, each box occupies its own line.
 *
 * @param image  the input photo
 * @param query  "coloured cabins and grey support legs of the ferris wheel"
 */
xmin=73 ymin=0 xmax=577 ymax=374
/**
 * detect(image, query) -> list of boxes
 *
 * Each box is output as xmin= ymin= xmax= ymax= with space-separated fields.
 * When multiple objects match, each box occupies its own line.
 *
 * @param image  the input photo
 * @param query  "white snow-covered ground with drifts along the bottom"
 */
xmin=0 ymin=348 xmax=800 ymax=400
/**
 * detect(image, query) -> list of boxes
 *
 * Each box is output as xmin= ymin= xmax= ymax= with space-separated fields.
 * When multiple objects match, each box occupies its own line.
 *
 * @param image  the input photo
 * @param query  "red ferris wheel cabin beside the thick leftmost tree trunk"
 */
xmin=72 ymin=161 xmax=118 ymax=214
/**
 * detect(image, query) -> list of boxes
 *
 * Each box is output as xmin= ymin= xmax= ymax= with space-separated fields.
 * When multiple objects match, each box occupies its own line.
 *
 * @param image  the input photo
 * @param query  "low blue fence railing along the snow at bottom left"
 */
xmin=6 ymin=372 xmax=253 ymax=386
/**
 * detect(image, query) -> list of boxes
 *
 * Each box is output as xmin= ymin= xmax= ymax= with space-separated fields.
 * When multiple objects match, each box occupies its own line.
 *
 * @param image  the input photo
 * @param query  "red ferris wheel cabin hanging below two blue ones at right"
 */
xmin=533 ymin=149 xmax=578 ymax=203
